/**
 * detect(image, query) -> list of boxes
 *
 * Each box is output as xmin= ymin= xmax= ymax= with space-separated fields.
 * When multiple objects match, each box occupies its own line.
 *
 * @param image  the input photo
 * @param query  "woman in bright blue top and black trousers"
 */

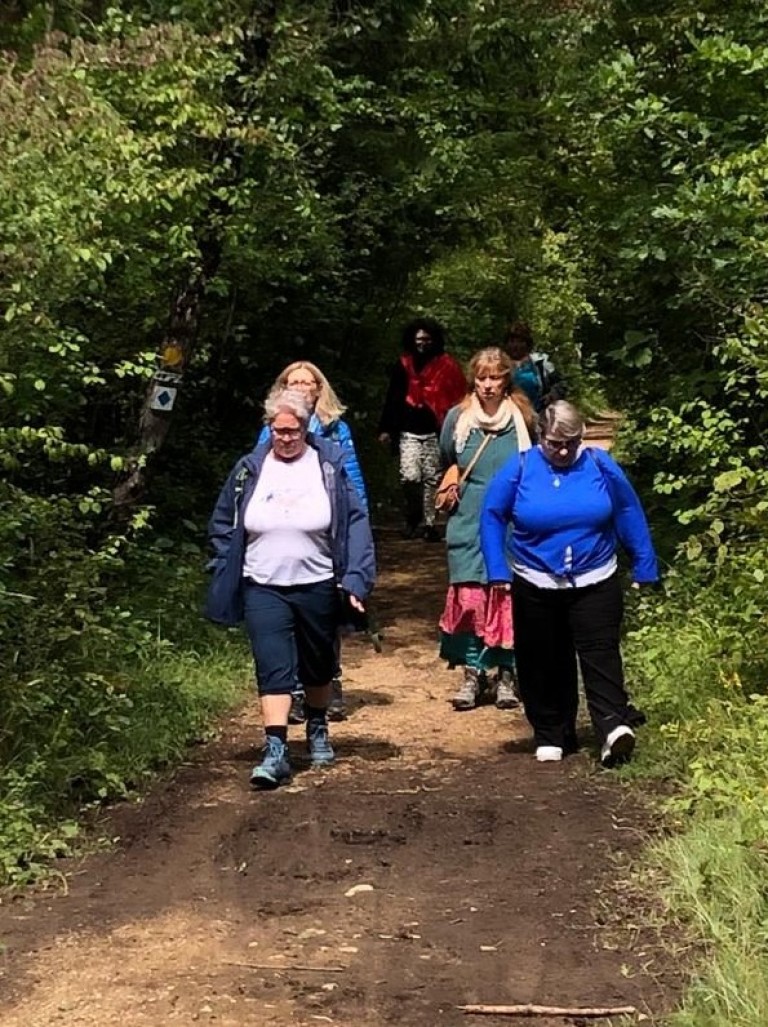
xmin=481 ymin=400 xmax=658 ymax=766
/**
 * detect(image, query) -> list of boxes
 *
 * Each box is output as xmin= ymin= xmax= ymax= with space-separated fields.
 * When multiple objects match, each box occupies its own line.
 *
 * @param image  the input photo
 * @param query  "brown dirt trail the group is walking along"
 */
xmin=0 ymin=533 xmax=676 ymax=1027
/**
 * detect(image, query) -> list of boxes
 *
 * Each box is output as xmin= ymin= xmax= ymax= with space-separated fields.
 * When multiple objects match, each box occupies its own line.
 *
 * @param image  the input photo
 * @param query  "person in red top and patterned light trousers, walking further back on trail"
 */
xmin=379 ymin=317 xmax=467 ymax=542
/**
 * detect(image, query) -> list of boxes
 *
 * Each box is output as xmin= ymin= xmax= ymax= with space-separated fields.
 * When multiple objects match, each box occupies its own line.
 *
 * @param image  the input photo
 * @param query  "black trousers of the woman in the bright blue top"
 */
xmin=512 ymin=574 xmax=630 ymax=749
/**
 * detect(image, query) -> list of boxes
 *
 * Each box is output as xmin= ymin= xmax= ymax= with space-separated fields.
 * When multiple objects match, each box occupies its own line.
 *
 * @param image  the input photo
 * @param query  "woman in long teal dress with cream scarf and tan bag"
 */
xmin=439 ymin=347 xmax=534 ymax=710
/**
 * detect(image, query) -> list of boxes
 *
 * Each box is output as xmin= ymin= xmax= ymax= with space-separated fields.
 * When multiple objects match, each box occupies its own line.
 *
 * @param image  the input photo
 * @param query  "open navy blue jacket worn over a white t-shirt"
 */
xmin=205 ymin=432 xmax=376 ymax=625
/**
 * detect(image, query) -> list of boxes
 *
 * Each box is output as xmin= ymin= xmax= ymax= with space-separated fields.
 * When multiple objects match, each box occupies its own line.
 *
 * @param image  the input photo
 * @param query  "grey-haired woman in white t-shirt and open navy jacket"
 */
xmin=206 ymin=389 xmax=376 ymax=789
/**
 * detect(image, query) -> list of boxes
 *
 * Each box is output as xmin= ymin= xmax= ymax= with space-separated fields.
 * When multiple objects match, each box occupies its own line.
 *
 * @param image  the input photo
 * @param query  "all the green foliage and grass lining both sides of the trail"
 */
xmin=0 ymin=32 xmax=768 ymax=1027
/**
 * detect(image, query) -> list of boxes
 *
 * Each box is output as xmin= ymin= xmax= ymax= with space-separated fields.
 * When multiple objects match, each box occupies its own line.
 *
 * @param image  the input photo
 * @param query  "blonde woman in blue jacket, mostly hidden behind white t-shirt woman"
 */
xmin=257 ymin=360 xmax=368 ymax=724
